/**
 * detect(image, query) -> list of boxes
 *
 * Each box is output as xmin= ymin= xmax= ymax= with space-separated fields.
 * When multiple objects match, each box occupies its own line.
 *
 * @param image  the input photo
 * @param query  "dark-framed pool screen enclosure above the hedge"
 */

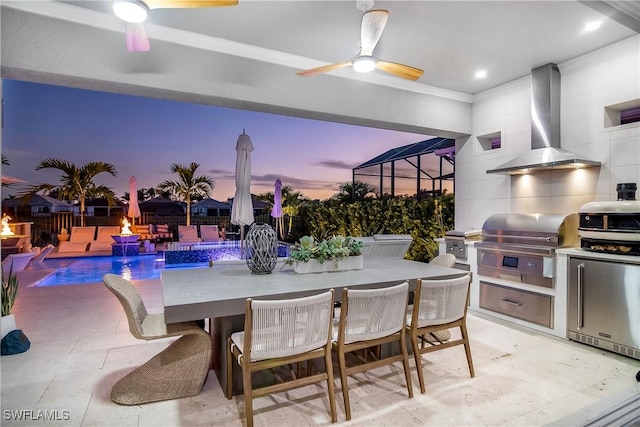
xmin=352 ymin=138 xmax=455 ymax=197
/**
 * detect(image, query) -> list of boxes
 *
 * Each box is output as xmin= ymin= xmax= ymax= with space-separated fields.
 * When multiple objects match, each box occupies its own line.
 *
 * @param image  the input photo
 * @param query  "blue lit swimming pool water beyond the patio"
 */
xmin=36 ymin=255 xmax=207 ymax=286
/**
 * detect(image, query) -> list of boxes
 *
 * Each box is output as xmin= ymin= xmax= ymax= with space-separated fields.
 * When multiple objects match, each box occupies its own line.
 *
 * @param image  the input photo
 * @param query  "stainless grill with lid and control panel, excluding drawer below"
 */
xmin=475 ymin=214 xmax=579 ymax=288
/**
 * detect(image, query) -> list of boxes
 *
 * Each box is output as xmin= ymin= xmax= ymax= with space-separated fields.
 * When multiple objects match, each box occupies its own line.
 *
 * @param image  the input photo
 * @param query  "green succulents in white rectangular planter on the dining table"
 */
xmin=285 ymin=236 xmax=363 ymax=273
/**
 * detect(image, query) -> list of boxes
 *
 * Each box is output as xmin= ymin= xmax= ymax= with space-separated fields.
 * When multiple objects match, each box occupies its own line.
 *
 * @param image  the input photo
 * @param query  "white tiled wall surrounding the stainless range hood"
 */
xmin=455 ymin=36 xmax=640 ymax=230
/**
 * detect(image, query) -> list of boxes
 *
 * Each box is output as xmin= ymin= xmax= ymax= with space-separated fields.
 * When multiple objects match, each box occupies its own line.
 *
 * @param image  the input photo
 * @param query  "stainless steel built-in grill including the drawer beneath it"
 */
xmin=475 ymin=214 xmax=578 ymax=329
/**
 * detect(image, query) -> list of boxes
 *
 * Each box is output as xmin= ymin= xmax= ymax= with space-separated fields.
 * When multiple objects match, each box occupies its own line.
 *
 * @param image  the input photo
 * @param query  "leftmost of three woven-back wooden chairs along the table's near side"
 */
xmin=226 ymin=289 xmax=337 ymax=427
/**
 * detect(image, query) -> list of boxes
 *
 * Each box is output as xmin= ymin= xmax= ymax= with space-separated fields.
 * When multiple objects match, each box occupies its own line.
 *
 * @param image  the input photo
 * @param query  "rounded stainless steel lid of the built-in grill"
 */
xmin=482 ymin=214 xmax=579 ymax=248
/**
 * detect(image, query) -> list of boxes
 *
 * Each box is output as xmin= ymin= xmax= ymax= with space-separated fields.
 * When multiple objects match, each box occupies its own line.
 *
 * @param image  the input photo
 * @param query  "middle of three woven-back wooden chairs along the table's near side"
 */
xmin=332 ymin=282 xmax=413 ymax=421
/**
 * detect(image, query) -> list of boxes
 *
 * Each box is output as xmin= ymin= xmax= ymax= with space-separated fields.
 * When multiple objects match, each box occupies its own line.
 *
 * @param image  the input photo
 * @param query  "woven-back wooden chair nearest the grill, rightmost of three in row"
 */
xmin=406 ymin=274 xmax=475 ymax=393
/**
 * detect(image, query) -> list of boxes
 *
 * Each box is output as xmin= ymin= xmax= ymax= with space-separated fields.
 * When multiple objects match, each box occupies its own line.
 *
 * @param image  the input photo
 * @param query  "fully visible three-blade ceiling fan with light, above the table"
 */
xmin=296 ymin=9 xmax=424 ymax=80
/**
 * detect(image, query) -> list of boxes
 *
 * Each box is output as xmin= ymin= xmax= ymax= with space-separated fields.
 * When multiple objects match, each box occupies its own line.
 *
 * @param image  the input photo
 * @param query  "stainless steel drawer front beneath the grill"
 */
xmin=480 ymin=281 xmax=553 ymax=328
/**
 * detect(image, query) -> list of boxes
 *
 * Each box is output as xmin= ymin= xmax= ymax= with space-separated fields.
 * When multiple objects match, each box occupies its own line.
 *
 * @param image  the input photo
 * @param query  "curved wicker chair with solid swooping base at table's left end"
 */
xmin=103 ymin=274 xmax=212 ymax=405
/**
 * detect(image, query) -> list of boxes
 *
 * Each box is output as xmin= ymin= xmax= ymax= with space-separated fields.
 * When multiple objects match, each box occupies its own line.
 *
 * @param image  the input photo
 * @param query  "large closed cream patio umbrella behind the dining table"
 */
xmin=231 ymin=129 xmax=254 ymax=246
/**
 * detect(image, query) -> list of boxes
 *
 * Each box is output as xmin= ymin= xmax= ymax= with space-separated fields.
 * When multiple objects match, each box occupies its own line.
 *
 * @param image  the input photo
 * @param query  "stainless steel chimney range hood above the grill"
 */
xmin=487 ymin=64 xmax=600 ymax=175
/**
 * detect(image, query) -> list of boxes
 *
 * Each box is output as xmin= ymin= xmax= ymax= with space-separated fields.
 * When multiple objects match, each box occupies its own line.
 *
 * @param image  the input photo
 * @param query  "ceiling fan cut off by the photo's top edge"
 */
xmin=113 ymin=0 xmax=238 ymax=52
